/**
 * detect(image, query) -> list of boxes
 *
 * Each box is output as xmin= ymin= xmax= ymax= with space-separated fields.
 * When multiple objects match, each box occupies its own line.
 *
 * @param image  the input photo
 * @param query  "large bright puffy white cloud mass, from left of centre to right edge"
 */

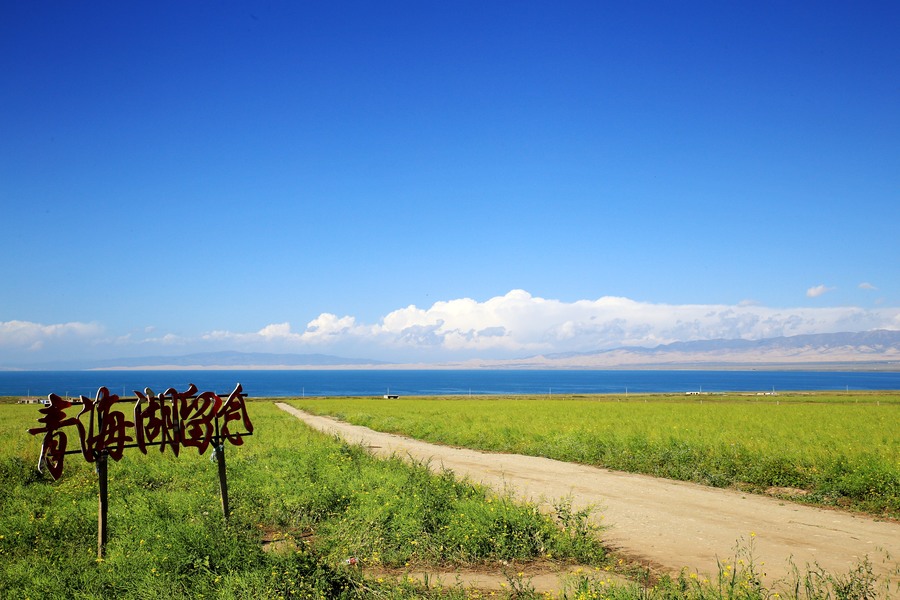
xmin=213 ymin=290 xmax=900 ymax=359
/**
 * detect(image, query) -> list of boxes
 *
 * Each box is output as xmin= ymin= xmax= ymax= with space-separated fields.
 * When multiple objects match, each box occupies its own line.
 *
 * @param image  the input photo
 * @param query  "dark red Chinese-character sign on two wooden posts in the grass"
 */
xmin=28 ymin=383 xmax=253 ymax=559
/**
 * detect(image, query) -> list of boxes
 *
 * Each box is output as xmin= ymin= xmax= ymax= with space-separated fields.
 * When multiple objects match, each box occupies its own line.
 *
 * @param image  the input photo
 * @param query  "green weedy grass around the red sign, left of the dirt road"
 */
xmin=0 ymin=394 xmax=896 ymax=600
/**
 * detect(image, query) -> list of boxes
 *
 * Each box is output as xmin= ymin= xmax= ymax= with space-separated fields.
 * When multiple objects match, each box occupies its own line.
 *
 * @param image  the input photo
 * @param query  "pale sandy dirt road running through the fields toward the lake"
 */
xmin=277 ymin=403 xmax=900 ymax=580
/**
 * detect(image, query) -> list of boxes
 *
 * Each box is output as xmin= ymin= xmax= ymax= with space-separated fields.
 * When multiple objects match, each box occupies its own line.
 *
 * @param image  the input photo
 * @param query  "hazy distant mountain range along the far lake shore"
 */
xmin=14 ymin=329 xmax=900 ymax=370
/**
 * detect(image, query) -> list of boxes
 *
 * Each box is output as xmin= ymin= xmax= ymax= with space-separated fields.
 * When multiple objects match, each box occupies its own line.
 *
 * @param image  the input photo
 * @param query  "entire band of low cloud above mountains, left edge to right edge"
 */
xmin=0 ymin=290 xmax=900 ymax=366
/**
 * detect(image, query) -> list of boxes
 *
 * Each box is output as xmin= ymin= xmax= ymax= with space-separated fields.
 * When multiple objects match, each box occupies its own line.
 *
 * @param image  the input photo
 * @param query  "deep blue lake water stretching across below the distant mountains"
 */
xmin=0 ymin=370 xmax=900 ymax=397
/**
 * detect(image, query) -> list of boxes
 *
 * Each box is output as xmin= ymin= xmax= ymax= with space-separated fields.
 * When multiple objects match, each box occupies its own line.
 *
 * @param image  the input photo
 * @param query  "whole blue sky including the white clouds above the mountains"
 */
xmin=0 ymin=1 xmax=900 ymax=367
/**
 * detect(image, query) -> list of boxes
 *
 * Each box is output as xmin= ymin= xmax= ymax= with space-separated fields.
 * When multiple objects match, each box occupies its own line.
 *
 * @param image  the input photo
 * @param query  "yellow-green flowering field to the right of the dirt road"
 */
xmin=291 ymin=393 xmax=900 ymax=518
